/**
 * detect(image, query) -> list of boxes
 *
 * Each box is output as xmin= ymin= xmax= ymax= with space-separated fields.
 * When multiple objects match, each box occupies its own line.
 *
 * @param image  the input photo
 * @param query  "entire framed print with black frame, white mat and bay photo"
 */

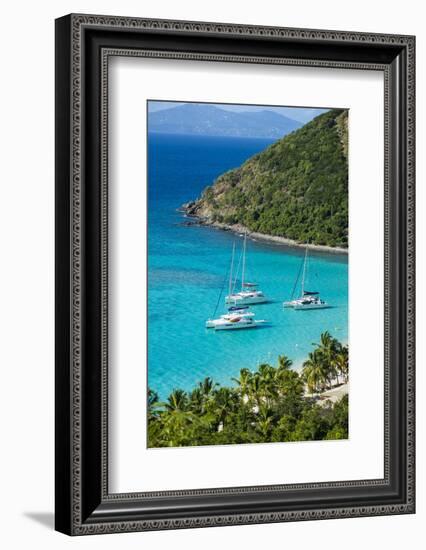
xmin=56 ymin=15 xmax=415 ymax=535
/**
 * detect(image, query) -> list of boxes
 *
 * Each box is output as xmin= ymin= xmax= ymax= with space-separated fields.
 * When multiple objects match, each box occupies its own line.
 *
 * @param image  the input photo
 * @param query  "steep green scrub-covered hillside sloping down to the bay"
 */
xmin=181 ymin=109 xmax=348 ymax=251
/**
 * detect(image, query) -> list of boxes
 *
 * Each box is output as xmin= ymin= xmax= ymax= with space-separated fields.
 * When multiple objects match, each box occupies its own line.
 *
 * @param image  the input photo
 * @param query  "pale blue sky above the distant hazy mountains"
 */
xmin=148 ymin=101 xmax=328 ymax=123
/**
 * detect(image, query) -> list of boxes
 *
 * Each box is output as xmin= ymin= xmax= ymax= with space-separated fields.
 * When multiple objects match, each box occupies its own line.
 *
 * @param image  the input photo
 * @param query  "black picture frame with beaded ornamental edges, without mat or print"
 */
xmin=55 ymin=14 xmax=415 ymax=535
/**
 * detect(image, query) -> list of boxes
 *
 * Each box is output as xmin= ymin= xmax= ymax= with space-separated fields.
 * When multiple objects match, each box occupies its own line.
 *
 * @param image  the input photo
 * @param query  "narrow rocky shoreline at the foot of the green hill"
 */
xmin=178 ymin=206 xmax=348 ymax=255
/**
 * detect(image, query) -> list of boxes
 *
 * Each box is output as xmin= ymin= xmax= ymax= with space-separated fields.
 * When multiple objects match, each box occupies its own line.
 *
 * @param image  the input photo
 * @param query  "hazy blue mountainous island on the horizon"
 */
xmin=148 ymin=103 xmax=303 ymax=138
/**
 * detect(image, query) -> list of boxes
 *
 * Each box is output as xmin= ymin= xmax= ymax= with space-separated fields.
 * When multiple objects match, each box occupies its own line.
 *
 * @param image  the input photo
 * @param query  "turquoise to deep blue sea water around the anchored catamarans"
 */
xmin=148 ymin=134 xmax=348 ymax=399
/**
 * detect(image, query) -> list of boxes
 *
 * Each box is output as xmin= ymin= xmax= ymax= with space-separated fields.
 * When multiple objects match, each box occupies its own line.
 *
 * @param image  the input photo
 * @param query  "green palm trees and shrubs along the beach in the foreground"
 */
xmin=148 ymin=332 xmax=349 ymax=448
